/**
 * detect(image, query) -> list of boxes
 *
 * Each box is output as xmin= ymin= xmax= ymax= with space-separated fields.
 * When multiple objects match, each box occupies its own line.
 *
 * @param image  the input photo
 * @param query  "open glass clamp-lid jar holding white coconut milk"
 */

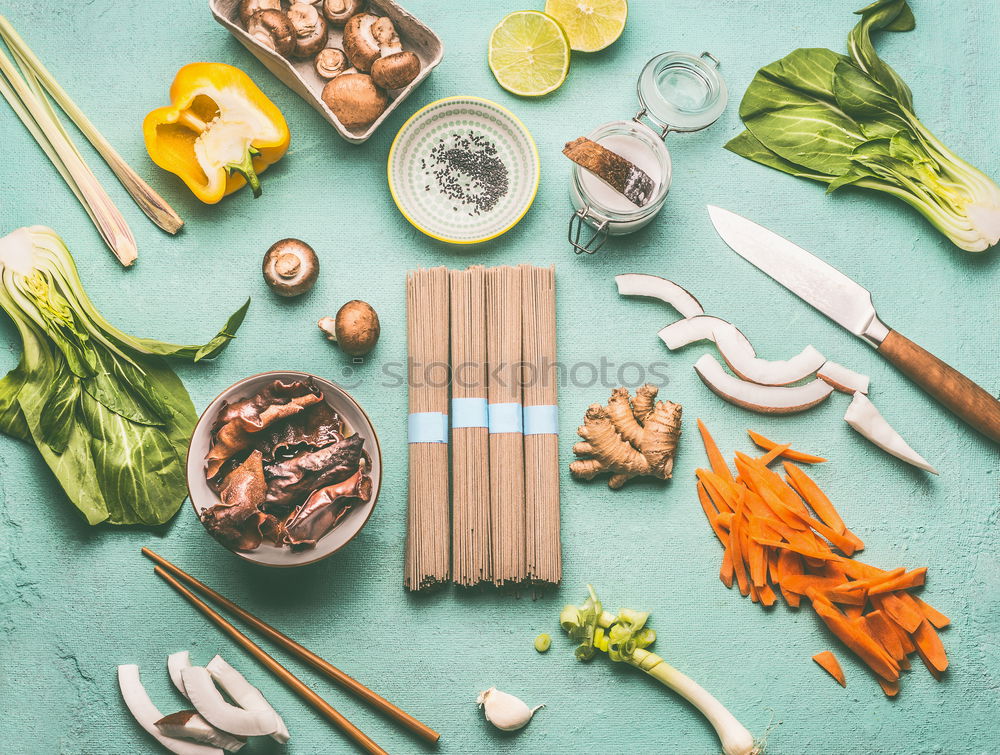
xmin=569 ymin=52 xmax=727 ymax=254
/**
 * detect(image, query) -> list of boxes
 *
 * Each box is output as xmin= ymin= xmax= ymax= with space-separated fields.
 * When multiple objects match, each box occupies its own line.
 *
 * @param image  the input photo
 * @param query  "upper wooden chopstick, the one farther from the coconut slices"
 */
xmin=142 ymin=548 xmax=441 ymax=742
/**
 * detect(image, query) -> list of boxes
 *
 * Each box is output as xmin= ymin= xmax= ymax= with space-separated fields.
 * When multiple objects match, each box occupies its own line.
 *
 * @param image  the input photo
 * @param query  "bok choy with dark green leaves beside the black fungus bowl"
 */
xmin=0 ymin=226 xmax=250 ymax=524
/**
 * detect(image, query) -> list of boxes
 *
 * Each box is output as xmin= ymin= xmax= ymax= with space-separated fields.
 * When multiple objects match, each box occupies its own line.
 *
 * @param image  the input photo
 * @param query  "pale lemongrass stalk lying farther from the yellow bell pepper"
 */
xmin=0 ymin=44 xmax=138 ymax=267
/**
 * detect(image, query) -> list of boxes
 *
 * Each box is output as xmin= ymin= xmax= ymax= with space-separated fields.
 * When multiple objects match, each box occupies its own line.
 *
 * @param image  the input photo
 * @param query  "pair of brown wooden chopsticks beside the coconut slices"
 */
xmin=142 ymin=548 xmax=441 ymax=755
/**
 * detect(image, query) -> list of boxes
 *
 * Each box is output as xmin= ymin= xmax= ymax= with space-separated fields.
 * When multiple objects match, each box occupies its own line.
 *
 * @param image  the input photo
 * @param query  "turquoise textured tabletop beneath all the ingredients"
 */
xmin=0 ymin=0 xmax=1000 ymax=755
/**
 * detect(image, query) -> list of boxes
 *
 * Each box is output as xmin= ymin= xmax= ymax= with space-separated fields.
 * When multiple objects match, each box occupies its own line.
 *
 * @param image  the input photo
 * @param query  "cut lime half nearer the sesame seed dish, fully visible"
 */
xmin=489 ymin=10 xmax=569 ymax=97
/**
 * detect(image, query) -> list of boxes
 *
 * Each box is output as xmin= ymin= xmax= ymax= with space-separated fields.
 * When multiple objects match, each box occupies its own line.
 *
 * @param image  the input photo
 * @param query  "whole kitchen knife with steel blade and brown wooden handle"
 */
xmin=708 ymin=205 xmax=1000 ymax=443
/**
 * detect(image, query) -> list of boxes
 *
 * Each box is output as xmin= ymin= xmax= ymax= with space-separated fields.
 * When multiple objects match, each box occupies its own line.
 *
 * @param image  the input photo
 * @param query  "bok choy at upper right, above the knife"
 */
xmin=726 ymin=0 xmax=1000 ymax=252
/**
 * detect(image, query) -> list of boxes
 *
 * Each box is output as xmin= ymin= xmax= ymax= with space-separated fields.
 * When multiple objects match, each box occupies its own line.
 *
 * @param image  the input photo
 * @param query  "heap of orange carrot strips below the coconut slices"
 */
xmin=697 ymin=421 xmax=949 ymax=696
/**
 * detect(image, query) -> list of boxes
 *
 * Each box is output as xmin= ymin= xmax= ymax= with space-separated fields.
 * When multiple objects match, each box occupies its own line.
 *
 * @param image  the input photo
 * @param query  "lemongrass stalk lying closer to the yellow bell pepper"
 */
xmin=0 ymin=16 xmax=184 ymax=233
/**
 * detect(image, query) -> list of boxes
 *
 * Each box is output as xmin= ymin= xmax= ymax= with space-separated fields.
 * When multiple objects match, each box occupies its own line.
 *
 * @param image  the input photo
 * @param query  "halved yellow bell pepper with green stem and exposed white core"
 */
xmin=142 ymin=63 xmax=291 ymax=204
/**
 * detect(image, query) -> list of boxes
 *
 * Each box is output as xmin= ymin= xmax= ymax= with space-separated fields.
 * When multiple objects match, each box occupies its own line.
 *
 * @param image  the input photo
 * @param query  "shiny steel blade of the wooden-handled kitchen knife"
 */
xmin=708 ymin=205 xmax=889 ymax=347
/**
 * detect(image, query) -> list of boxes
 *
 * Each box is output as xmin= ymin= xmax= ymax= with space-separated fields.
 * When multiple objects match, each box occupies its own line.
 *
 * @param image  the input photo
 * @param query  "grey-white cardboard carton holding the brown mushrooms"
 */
xmin=209 ymin=0 xmax=444 ymax=144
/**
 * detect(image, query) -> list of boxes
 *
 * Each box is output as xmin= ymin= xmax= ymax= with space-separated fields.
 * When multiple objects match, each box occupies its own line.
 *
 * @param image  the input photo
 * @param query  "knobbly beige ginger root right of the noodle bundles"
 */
xmin=569 ymin=385 xmax=681 ymax=490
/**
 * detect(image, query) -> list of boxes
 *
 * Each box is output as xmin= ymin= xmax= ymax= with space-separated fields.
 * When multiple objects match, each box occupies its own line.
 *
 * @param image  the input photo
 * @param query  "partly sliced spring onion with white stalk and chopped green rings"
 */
xmin=559 ymin=585 xmax=763 ymax=755
